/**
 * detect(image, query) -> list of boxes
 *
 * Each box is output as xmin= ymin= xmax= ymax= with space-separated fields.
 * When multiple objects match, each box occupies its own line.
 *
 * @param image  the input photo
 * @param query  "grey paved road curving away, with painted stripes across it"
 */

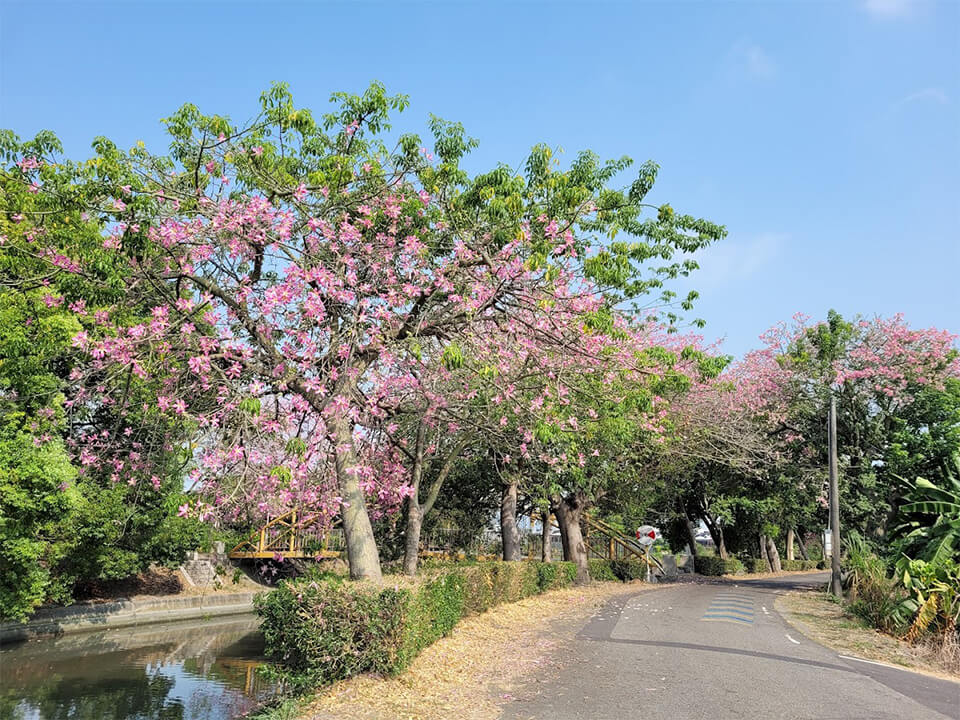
xmin=503 ymin=573 xmax=960 ymax=720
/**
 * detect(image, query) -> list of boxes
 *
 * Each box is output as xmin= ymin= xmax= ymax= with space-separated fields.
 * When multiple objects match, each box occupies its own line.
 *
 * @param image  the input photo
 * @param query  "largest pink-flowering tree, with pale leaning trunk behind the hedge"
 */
xmin=9 ymin=85 xmax=724 ymax=579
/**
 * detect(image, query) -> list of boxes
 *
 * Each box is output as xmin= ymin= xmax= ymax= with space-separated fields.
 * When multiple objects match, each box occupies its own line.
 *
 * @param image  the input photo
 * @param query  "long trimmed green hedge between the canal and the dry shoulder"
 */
xmin=256 ymin=562 xmax=576 ymax=691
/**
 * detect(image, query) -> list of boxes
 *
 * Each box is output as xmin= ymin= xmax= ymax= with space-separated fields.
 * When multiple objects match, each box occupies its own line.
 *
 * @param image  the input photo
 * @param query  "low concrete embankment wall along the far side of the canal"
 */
xmin=0 ymin=592 xmax=258 ymax=644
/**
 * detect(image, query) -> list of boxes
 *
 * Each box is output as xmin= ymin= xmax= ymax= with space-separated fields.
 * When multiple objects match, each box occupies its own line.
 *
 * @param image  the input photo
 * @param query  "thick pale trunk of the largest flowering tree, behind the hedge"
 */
xmin=332 ymin=418 xmax=383 ymax=581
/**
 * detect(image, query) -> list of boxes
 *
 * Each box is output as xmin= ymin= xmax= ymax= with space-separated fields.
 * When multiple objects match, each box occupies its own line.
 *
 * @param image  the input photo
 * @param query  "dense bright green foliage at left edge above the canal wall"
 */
xmin=0 ymin=149 xmax=216 ymax=618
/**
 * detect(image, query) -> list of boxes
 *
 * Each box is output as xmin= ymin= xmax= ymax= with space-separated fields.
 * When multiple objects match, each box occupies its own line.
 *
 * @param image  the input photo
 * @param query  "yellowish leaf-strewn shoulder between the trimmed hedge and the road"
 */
xmin=298 ymin=583 xmax=669 ymax=720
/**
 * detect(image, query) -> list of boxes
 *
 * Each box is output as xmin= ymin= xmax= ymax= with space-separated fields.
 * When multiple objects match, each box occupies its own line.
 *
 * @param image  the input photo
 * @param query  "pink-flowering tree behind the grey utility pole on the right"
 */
xmin=734 ymin=311 xmax=960 ymax=532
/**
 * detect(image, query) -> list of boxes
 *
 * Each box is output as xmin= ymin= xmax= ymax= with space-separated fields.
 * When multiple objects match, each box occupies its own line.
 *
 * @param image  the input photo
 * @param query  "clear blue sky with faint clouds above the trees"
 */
xmin=0 ymin=0 xmax=960 ymax=354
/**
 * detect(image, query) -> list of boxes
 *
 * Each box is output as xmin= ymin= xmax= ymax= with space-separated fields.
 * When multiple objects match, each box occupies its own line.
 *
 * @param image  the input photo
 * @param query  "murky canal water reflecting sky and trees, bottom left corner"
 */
xmin=0 ymin=616 xmax=272 ymax=720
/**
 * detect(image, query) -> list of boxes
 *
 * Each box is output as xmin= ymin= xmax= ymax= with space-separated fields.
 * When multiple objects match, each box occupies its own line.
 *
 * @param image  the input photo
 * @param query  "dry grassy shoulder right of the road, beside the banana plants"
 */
xmin=774 ymin=592 xmax=960 ymax=681
